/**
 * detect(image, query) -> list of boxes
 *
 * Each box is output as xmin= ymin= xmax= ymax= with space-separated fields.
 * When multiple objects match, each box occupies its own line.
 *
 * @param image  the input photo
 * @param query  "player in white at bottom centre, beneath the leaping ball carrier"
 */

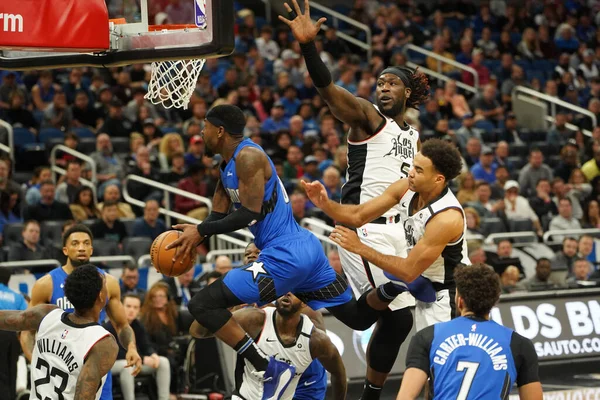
xmin=190 ymin=293 xmax=347 ymax=400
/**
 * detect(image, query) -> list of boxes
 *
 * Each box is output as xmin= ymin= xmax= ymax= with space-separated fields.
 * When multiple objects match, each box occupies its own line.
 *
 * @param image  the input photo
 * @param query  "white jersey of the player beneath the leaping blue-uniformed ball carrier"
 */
xmin=235 ymin=307 xmax=313 ymax=400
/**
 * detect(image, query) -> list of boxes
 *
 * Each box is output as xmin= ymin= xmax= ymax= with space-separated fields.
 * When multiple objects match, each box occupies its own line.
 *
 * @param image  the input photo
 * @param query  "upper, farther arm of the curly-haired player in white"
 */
xmin=302 ymin=179 xmax=408 ymax=227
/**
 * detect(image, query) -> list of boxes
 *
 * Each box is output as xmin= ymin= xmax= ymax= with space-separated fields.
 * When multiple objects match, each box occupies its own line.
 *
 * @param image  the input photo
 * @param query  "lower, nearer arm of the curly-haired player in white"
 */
xmin=330 ymin=209 xmax=464 ymax=282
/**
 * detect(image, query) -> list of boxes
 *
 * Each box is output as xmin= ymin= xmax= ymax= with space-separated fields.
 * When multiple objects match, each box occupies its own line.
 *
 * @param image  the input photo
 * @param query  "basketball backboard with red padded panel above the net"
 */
xmin=0 ymin=0 xmax=234 ymax=70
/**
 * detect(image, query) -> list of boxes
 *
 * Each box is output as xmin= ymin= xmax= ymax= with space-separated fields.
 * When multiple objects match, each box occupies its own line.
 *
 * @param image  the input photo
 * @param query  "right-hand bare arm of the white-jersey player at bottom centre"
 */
xmin=310 ymin=328 xmax=348 ymax=400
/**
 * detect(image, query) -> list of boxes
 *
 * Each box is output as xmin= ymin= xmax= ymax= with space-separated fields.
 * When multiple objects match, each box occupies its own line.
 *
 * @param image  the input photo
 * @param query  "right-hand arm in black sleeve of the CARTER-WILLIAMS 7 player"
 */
xmin=510 ymin=332 xmax=543 ymax=400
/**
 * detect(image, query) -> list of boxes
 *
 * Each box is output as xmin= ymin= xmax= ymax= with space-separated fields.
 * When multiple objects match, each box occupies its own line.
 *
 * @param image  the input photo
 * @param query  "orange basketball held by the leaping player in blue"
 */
xmin=150 ymin=230 xmax=195 ymax=276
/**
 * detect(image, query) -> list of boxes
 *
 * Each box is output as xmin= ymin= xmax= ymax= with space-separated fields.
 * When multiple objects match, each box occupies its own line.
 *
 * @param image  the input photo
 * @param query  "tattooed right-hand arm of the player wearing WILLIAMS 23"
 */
xmin=74 ymin=335 xmax=119 ymax=400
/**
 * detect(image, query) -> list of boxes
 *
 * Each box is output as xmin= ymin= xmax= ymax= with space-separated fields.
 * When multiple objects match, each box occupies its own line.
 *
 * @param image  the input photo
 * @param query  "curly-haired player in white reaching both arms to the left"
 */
xmin=305 ymin=139 xmax=471 ymax=329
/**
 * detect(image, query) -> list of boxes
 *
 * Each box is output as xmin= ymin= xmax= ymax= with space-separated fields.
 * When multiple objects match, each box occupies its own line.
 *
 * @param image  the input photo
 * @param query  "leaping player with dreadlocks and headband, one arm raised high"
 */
xmin=279 ymin=0 xmax=429 ymax=400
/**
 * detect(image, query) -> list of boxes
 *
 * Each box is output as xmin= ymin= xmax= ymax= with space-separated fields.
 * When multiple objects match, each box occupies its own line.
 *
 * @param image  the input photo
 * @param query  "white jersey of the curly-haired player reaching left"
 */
xmin=400 ymin=187 xmax=471 ymax=284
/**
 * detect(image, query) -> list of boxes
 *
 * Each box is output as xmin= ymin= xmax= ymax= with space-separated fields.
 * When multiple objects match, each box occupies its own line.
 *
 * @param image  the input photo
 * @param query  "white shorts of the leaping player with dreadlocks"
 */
xmin=338 ymin=221 xmax=415 ymax=310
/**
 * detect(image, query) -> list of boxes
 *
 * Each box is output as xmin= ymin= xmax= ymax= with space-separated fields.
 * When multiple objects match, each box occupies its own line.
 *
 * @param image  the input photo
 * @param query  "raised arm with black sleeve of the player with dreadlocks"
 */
xmin=279 ymin=0 xmax=382 ymax=133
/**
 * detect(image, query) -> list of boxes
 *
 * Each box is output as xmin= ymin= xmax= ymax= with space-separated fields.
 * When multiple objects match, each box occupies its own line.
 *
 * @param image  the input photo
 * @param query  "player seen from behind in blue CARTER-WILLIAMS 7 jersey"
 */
xmin=398 ymin=264 xmax=543 ymax=400
